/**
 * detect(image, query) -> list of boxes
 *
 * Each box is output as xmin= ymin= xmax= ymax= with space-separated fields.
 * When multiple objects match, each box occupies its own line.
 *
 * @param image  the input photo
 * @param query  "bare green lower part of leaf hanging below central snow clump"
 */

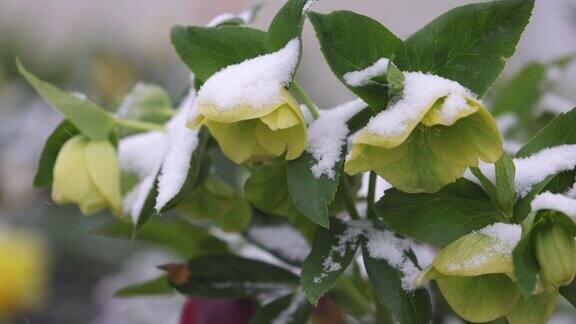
xmin=287 ymin=151 xmax=344 ymax=228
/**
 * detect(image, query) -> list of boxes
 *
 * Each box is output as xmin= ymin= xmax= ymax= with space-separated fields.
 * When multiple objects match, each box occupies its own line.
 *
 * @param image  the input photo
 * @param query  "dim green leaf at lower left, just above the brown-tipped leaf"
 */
xmin=90 ymin=218 xmax=227 ymax=258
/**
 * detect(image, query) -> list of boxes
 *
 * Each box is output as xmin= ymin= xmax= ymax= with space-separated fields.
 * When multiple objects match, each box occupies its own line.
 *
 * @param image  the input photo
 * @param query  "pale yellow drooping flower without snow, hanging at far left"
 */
xmin=52 ymin=135 xmax=122 ymax=215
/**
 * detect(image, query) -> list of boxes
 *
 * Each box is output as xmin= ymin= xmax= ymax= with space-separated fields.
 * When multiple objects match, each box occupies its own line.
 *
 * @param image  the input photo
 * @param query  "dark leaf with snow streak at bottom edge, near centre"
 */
xmin=250 ymin=292 xmax=312 ymax=324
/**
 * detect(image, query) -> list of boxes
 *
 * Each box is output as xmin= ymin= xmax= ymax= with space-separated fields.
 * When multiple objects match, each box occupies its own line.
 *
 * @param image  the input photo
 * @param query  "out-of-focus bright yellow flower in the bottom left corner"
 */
xmin=0 ymin=229 xmax=47 ymax=316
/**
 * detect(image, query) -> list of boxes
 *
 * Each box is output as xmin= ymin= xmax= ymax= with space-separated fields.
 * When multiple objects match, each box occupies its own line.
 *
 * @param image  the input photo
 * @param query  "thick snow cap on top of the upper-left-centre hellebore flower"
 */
xmin=195 ymin=38 xmax=300 ymax=111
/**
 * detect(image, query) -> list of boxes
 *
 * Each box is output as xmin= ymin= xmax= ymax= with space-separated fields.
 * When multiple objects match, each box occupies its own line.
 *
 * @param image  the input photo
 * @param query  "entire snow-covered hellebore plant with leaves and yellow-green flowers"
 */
xmin=18 ymin=0 xmax=576 ymax=324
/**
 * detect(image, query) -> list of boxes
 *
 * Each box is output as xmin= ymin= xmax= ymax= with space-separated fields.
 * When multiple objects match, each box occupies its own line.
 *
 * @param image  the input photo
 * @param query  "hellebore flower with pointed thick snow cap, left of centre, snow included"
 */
xmin=188 ymin=39 xmax=307 ymax=163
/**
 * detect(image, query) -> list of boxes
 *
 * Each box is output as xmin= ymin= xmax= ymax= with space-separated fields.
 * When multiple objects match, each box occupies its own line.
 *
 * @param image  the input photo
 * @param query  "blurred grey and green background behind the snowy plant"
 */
xmin=0 ymin=0 xmax=576 ymax=324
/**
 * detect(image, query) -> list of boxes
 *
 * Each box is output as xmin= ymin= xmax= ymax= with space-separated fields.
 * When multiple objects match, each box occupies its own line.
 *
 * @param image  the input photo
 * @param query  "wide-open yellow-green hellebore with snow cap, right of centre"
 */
xmin=345 ymin=72 xmax=502 ymax=193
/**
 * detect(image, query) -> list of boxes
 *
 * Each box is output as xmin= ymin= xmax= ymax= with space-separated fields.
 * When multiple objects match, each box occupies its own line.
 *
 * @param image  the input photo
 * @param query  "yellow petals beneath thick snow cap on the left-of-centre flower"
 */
xmin=188 ymin=89 xmax=306 ymax=163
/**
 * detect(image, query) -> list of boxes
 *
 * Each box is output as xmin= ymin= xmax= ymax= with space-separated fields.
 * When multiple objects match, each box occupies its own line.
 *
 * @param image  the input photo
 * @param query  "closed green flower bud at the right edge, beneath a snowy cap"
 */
xmin=536 ymin=223 xmax=576 ymax=287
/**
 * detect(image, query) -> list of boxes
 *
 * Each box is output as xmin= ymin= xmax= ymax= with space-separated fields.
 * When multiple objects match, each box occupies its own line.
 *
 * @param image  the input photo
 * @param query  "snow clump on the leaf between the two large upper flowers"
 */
xmin=307 ymin=99 xmax=366 ymax=179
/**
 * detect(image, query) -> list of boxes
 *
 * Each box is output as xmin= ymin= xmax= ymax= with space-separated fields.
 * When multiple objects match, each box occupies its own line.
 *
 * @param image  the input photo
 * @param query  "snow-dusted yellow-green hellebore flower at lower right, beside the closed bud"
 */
xmin=416 ymin=223 xmax=521 ymax=322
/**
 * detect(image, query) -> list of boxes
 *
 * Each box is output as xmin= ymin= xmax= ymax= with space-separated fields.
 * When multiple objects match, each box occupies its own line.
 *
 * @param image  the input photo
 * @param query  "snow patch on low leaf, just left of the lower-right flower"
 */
xmin=367 ymin=230 xmax=421 ymax=291
